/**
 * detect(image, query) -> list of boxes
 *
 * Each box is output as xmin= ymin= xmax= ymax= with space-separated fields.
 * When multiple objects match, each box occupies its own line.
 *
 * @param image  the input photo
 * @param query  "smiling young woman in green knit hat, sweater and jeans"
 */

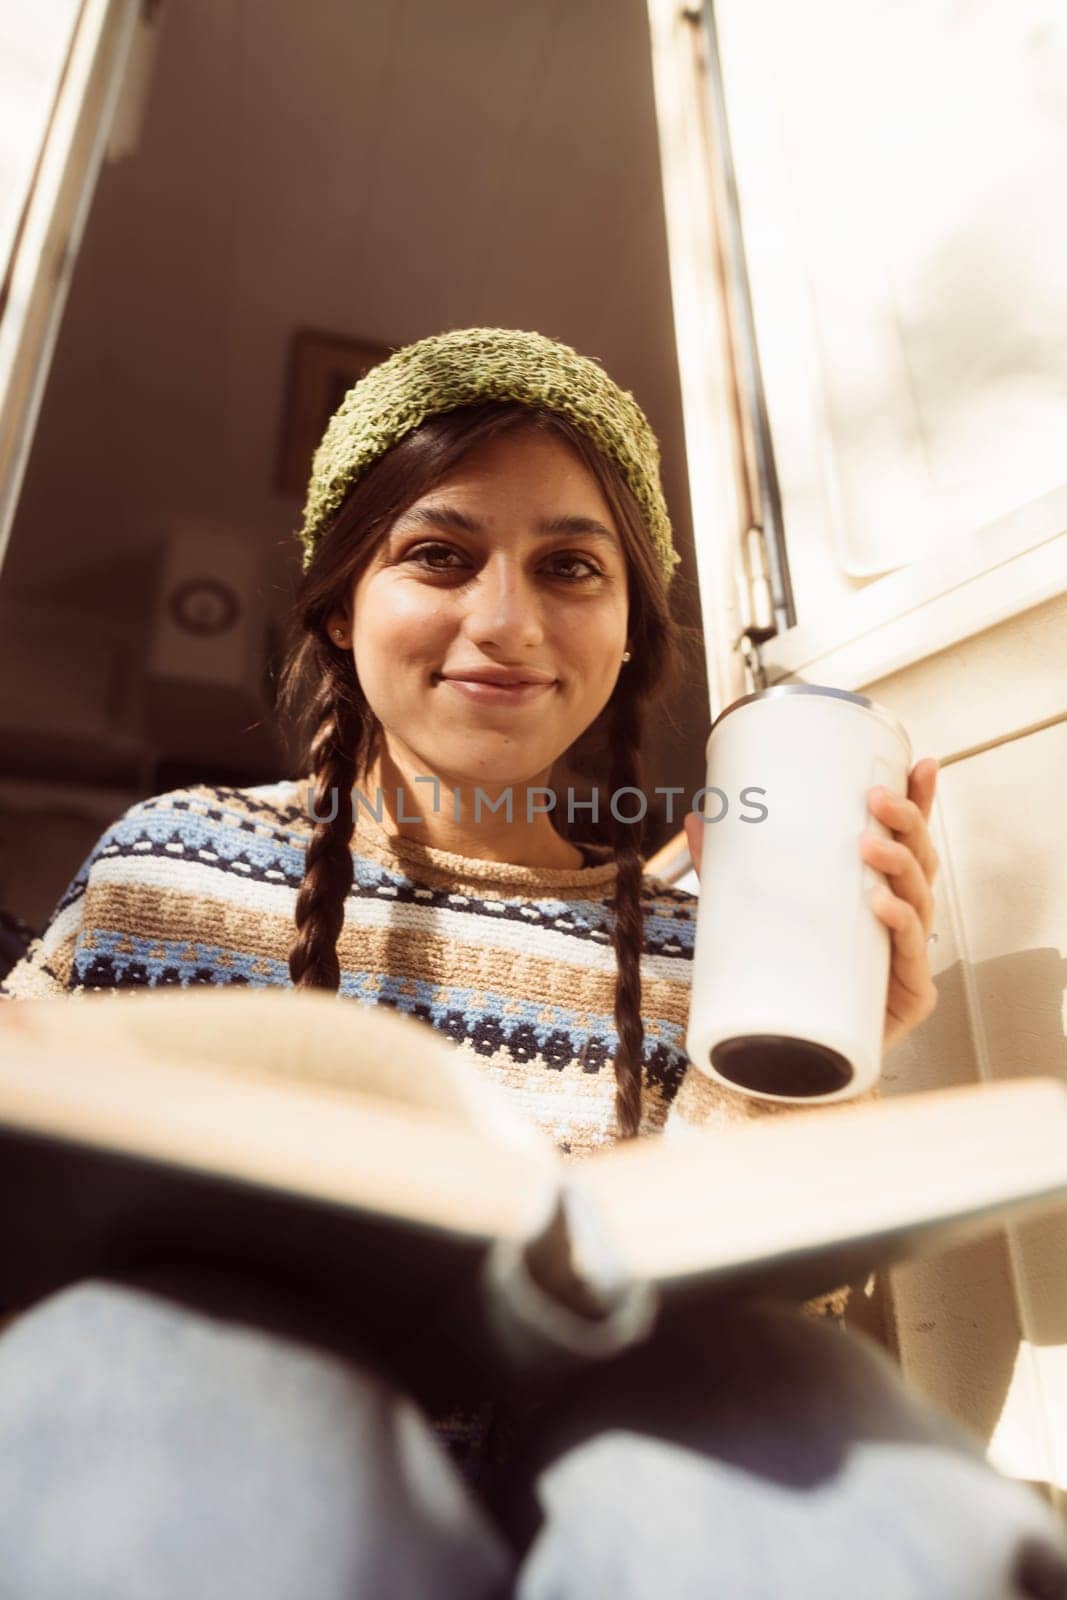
xmin=0 ymin=328 xmax=1067 ymax=1600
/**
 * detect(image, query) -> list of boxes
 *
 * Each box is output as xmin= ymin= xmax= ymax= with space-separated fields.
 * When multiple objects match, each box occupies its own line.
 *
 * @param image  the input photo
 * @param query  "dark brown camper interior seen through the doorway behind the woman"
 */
xmin=0 ymin=0 xmax=709 ymax=928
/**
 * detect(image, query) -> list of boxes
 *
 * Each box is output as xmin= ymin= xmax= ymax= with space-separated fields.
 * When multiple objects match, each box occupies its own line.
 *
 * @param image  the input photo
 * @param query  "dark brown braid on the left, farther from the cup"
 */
xmin=290 ymin=661 xmax=365 ymax=992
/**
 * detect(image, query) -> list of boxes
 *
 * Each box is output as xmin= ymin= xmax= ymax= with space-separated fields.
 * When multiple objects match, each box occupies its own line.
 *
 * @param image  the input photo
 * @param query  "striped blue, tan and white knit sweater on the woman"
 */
xmin=0 ymin=779 xmax=848 ymax=1482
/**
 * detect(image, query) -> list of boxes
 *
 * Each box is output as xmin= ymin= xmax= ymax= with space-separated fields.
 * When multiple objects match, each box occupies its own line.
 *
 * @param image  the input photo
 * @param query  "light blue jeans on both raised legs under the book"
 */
xmin=0 ymin=1280 xmax=1067 ymax=1600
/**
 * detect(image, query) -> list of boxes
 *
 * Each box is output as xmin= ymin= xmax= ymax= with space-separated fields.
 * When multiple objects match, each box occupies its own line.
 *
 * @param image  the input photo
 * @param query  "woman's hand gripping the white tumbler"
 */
xmin=685 ymin=755 xmax=937 ymax=1050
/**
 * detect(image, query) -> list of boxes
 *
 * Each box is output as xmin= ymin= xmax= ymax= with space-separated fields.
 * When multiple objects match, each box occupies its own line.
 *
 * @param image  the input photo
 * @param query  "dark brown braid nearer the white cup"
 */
xmin=609 ymin=694 xmax=645 ymax=1139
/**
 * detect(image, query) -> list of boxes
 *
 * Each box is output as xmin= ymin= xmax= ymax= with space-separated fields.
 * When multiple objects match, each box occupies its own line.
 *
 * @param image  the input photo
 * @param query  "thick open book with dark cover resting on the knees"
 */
xmin=0 ymin=989 xmax=1067 ymax=1403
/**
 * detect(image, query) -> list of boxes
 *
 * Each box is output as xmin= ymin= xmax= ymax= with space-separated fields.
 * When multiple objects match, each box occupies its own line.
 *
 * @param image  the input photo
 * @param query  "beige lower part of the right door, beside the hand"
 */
xmin=870 ymin=672 xmax=1067 ymax=1509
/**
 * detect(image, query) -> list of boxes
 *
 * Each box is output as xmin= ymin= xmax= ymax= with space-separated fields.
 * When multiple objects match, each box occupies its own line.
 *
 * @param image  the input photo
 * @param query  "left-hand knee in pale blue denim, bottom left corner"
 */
xmin=0 ymin=1280 xmax=502 ymax=1600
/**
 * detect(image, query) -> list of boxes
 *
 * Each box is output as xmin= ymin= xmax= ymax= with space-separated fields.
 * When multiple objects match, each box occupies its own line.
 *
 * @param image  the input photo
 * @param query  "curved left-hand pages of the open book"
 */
xmin=0 ymin=992 xmax=558 ymax=1240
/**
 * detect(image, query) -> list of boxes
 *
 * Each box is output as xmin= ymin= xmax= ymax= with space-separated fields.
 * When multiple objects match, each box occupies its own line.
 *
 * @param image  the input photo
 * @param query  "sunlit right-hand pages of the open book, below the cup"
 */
xmin=566 ymin=1077 xmax=1067 ymax=1282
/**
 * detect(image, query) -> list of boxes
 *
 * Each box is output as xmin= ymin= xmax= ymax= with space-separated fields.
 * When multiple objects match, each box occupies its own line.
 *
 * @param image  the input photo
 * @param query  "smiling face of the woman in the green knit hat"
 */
xmin=328 ymin=434 xmax=629 ymax=786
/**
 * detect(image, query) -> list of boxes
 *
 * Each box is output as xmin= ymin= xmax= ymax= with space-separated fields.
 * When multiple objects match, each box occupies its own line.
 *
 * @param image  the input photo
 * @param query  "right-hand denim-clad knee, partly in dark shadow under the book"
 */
xmin=494 ymin=1302 xmax=1067 ymax=1600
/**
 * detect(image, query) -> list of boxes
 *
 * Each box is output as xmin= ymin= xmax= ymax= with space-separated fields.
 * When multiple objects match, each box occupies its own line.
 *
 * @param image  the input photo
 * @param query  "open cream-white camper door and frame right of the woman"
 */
xmin=648 ymin=0 xmax=1067 ymax=1510
